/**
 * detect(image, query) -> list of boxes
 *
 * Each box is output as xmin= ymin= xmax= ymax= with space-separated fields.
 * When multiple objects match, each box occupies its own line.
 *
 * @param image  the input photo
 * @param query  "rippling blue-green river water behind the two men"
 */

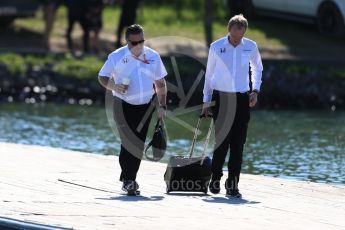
xmin=0 ymin=104 xmax=345 ymax=184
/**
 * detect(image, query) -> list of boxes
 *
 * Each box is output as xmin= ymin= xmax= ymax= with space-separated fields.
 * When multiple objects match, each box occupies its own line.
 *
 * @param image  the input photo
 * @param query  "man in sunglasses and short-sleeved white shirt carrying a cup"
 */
xmin=98 ymin=24 xmax=167 ymax=194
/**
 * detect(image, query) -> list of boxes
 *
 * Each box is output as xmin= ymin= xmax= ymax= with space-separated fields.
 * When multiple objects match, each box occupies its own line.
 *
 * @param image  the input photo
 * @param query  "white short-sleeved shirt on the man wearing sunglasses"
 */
xmin=99 ymin=45 xmax=167 ymax=105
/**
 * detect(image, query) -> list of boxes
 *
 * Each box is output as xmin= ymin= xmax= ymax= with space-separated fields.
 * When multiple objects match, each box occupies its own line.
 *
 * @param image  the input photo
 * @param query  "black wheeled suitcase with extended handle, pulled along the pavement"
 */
xmin=164 ymin=116 xmax=213 ymax=194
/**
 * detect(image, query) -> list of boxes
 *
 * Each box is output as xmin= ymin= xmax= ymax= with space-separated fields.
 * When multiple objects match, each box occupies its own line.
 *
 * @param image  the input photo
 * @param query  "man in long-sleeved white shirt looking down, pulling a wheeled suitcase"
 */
xmin=202 ymin=14 xmax=263 ymax=198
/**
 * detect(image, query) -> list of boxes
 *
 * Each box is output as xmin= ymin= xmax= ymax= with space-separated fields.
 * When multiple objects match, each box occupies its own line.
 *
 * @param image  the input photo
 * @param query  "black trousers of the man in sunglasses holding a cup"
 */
xmin=114 ymin=97 xmax=155 ymax=181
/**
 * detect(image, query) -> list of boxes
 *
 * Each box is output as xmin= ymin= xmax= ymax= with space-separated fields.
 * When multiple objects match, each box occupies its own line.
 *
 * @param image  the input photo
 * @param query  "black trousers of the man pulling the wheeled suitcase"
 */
xmin=212 ymin=90 xmax=250 ymax=190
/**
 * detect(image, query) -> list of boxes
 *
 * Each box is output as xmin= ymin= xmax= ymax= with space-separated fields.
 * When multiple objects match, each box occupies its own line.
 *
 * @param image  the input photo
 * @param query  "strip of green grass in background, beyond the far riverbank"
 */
xmin=15 ymin=6 xmax=345 ymax=48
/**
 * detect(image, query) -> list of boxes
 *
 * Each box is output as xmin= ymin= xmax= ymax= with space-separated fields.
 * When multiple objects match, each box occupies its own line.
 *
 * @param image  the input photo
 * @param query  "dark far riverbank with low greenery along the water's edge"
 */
xmin=0 ymin=53 xmax=345 ymax=110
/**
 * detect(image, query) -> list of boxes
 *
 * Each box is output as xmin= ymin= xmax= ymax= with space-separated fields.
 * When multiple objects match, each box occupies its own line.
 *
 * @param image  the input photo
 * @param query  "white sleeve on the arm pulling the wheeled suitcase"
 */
xmin=203 ymin=46 xmax=216 ymax=103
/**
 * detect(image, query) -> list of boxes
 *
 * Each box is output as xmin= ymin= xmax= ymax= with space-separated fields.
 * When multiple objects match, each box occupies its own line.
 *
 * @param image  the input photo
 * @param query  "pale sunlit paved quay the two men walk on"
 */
xmin=0 ymin=143 xmax=345 ymax=229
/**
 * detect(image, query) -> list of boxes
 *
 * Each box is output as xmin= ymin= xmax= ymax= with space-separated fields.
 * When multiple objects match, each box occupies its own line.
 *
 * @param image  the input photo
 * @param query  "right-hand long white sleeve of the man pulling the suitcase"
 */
xmin=249 ymin=43 xmax=263 ymax=91
